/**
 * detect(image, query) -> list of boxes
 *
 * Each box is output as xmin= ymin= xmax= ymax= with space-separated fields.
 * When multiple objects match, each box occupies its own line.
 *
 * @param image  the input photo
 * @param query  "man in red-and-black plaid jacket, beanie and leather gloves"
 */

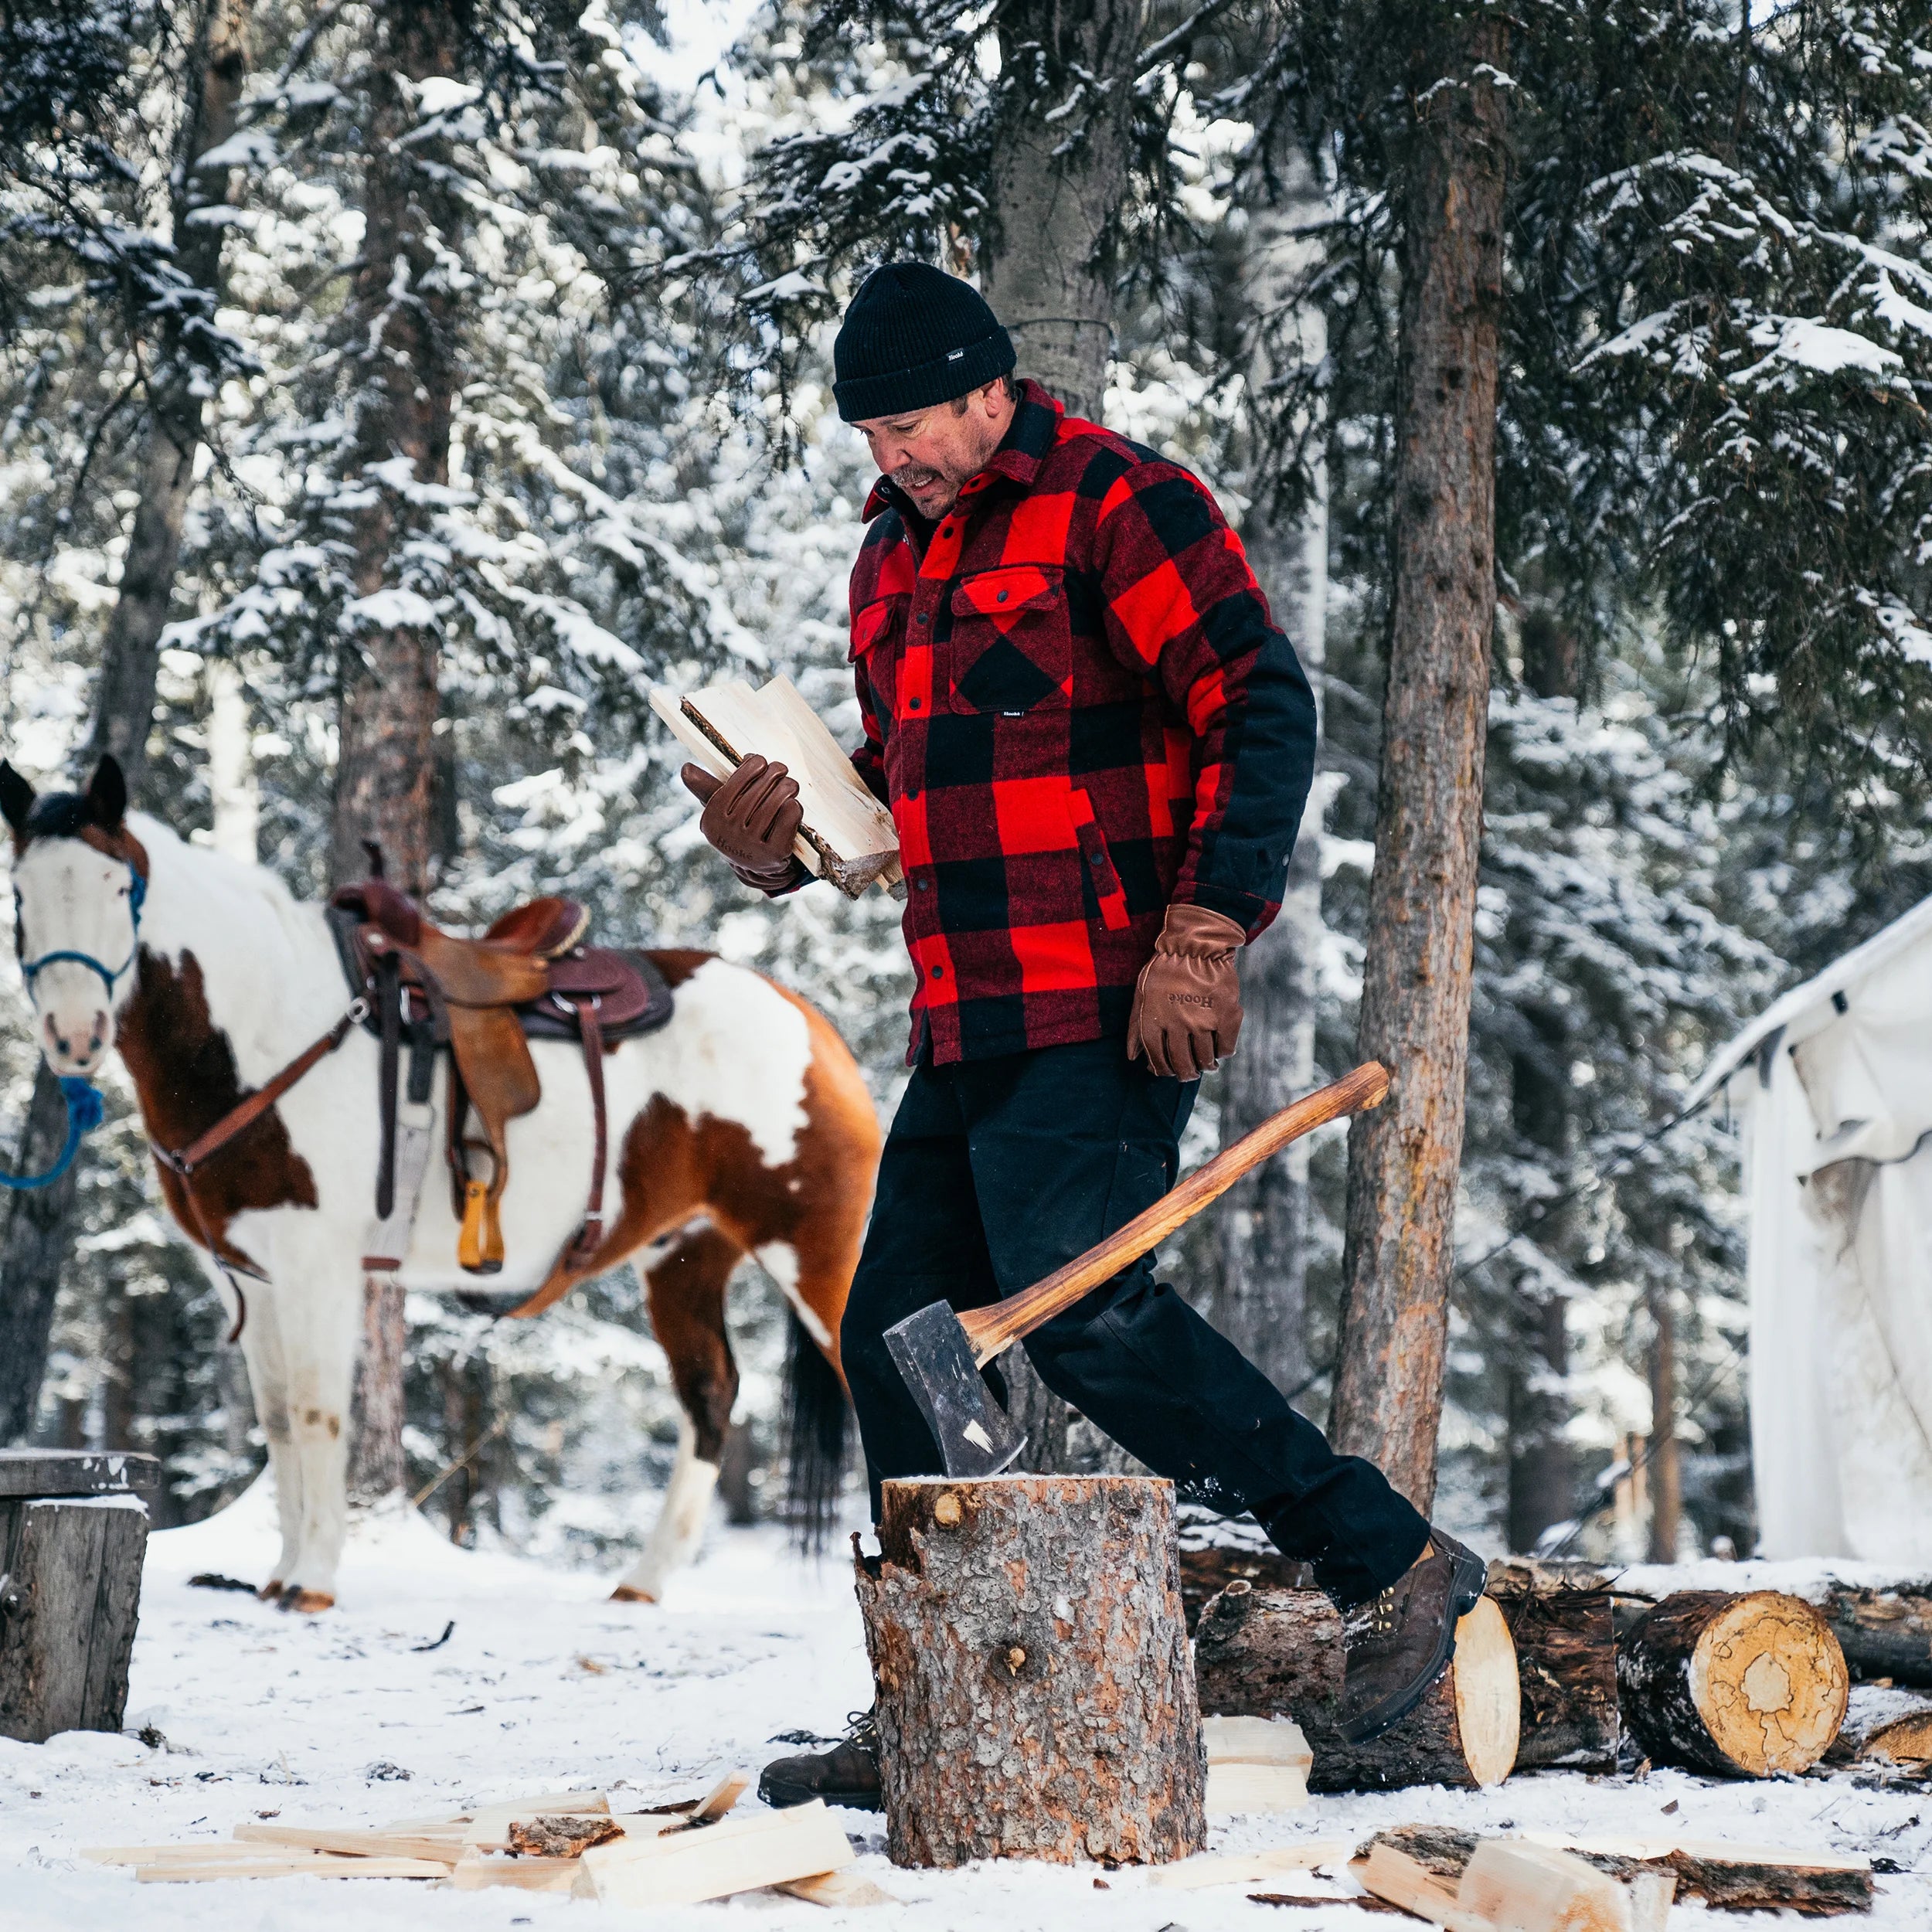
xmin=684 ymin=263 xmax=1484 ymax=1807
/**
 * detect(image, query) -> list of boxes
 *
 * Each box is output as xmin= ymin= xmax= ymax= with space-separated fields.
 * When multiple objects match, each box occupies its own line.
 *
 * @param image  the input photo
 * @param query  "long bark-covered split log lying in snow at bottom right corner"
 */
xmin=1370 ymin=1824 xmax=1872 ymax=1917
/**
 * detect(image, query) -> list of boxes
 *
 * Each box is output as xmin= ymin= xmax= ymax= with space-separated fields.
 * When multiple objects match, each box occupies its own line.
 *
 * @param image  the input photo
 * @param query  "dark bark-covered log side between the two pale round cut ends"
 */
xmin=1490 ymin=1563 xmax=1617 ymax=1772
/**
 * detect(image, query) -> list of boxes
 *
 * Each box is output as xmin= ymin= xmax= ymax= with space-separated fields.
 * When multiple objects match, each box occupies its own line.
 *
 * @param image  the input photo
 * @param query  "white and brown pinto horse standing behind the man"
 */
xmin=0 ymin=760 xmax=879 ymax=1610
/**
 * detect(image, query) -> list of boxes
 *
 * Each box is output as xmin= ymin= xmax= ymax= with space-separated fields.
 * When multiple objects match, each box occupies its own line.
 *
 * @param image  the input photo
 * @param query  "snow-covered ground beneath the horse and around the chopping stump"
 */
xmin=0 ymin=1490 xmax=1932 ymax=1932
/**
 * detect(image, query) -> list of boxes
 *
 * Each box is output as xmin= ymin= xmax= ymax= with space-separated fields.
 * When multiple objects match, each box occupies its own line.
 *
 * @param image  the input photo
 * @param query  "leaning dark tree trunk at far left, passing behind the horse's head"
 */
xmin=0 ymin=0 xmax=251 ymax=1444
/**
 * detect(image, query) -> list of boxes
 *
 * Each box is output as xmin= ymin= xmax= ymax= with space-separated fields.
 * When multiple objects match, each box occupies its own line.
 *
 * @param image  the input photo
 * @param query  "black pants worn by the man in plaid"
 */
xmin=838 ymin=1039 xmax=1428 ymax=1604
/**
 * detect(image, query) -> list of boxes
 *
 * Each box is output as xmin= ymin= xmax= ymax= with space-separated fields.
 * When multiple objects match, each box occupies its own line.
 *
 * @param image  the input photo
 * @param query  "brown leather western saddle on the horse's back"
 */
xmin=328 ymin=885 xmax=672 ymax=1287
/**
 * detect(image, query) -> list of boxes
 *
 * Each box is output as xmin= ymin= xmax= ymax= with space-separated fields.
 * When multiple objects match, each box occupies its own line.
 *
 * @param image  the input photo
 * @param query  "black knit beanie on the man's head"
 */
xmin=833 ymin=261 xmax=1019 ymax=423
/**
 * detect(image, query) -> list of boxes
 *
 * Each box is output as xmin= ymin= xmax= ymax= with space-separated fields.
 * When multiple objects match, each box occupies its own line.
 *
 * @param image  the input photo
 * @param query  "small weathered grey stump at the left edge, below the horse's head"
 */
xmin=0 ymin=1449 xmax=161 ymax=1745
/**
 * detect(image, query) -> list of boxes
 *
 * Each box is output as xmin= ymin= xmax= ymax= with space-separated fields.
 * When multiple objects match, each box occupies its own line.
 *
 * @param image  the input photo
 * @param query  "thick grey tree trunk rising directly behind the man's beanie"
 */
xmin=980 ymin=0 xmax=1144 ymax=421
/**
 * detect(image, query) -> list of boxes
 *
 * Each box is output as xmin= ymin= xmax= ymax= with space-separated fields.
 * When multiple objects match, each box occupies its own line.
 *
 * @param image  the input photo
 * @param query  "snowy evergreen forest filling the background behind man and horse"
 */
xmin=0 ymin=0 xmax=1932 ymax=1563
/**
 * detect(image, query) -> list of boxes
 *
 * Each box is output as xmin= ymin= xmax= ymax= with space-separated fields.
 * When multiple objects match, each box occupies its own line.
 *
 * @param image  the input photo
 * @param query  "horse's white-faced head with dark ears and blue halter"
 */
xmin=0 ymin=757 xmax=147 ymax=1074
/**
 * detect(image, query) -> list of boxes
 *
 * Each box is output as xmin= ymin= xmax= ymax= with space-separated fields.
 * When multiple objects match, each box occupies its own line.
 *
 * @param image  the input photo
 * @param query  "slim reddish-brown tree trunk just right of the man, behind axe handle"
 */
xmin=1329 ymin=15 xmax=1509 ymax=1513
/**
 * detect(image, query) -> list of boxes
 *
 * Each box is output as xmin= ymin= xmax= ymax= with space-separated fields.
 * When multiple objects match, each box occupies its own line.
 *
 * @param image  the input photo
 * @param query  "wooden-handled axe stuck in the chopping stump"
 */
xmin=885 ymin=1061 xmax=1389 ymax=1476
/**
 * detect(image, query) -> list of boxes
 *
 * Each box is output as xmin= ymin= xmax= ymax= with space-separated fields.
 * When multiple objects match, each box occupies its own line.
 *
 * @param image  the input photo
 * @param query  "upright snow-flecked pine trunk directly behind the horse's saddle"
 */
xmin=331 ymin=0 xmax=462 ymax=1502
